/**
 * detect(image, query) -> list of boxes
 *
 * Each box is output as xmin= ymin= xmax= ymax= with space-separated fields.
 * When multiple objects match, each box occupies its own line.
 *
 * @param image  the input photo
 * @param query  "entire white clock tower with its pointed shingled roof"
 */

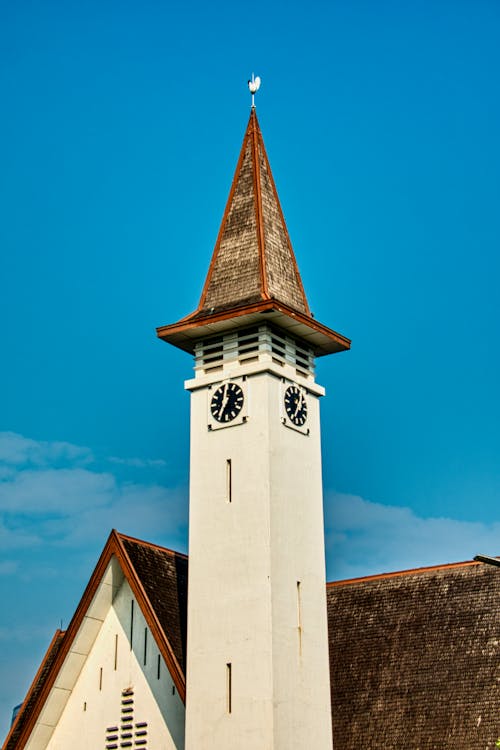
xmin=158 ymin=101 xmax=350 ymax=750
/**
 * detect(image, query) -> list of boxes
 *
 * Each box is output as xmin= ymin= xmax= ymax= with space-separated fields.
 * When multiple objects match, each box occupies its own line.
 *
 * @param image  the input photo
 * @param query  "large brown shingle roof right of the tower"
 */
xmin=327 ymin=563 xmax=500 ymax=750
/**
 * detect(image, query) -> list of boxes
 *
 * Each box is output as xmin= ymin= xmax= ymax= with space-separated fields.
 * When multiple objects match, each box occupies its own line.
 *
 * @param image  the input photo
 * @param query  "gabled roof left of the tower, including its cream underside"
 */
xmin=3 ymin=530 xmax=187 ymax=750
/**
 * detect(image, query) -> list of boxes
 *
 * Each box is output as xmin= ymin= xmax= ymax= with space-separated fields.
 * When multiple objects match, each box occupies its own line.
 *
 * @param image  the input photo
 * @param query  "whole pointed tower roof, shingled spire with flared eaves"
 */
xmin=157 ymin=108 xmax=350 ymax=355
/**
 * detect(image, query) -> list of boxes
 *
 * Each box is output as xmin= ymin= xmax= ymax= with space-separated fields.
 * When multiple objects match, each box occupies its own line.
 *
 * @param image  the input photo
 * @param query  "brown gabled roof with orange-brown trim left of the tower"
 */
xmin=3 ymin=530 xmax=188 ymax=750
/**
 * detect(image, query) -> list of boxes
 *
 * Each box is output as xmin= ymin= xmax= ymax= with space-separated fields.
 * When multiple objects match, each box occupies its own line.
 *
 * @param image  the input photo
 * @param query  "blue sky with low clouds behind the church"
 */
xmin=0 ymin=0 xmax=500 ymax=735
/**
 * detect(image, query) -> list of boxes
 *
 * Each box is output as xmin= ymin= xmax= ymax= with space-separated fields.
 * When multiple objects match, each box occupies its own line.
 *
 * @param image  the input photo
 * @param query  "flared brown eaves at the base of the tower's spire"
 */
xmin=156 ymin=300 xmax=351 ymax=357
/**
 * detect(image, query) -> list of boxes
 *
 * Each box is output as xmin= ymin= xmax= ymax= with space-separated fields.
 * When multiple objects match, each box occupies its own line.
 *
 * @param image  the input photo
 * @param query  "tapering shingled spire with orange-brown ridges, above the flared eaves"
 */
xmin=198 ymin=107 xmax=310 ymax=315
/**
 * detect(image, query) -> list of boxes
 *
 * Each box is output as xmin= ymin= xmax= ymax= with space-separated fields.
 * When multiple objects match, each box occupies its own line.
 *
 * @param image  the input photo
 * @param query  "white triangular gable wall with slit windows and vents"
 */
xmin=26 ymin=580 xmax=184 ymax=750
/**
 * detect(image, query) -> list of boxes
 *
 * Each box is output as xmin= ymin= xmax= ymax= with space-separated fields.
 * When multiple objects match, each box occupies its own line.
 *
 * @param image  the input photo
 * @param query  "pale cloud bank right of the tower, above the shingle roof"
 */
xmin=325 ymin=493 xmax=500 ymax=579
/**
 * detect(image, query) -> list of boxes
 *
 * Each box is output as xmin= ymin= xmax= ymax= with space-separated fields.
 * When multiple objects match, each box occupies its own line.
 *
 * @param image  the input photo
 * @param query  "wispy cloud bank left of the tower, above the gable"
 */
xmin=0 ymin=432 xmax=187 ymax=560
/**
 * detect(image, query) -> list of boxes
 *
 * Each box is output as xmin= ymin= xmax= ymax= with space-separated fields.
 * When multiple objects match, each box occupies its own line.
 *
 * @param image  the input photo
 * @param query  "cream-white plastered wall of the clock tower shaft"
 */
xmin=186 ymin=364 xmax=332 ymax=750
